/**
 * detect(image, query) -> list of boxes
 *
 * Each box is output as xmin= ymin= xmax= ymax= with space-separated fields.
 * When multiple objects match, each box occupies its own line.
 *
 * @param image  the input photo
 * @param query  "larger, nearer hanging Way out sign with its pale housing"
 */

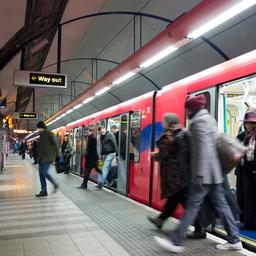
xmin=13 ymin=70 xmax=67 ymax=89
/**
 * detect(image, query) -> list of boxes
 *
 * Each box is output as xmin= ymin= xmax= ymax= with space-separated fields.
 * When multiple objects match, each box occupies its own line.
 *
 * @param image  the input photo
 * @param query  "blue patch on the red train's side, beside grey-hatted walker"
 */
xmin=140 ymin=122 xmax=163 ymax=152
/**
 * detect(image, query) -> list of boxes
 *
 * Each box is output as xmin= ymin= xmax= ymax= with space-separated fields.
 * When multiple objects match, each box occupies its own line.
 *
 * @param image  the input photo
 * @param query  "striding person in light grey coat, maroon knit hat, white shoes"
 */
xmin=155 ymin=95 xmax=242 ymax=253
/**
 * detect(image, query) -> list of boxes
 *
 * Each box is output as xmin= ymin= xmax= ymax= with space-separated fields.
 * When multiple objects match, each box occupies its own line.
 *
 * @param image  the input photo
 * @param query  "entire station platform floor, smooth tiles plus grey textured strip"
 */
xmin=0 ymin=155 xmax=255 ymax=256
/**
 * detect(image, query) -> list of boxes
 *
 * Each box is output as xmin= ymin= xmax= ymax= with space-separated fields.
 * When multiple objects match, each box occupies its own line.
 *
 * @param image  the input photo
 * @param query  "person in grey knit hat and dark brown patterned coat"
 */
xmin=148 ymin=113 xmax=189 ymax=229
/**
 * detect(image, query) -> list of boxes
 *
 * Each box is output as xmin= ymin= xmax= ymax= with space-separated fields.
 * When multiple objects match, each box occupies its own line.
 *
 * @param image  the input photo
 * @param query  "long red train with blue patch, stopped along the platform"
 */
xmin=55 ymin=50 xmax=256 ymax=216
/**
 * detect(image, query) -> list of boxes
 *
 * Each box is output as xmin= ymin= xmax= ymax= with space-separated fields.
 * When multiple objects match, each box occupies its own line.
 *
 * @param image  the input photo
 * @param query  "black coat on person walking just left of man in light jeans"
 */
xmin=85 ymin=134 xmax=99 ymax=168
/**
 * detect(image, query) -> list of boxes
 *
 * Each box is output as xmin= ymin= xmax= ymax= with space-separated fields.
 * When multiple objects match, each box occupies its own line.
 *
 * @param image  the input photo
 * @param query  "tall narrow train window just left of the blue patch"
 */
xmin=130 ymin=112 xmax=141 ymax=163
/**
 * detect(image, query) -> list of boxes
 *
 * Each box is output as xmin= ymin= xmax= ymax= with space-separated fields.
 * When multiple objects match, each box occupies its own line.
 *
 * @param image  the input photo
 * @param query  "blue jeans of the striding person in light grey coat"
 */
xmin=170 ymin=184 xmax=240 ymax=245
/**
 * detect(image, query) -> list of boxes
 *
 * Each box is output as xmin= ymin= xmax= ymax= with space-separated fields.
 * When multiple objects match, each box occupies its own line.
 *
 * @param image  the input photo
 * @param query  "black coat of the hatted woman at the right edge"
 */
xmin=236 ymin=132 xmax=256 ymax=225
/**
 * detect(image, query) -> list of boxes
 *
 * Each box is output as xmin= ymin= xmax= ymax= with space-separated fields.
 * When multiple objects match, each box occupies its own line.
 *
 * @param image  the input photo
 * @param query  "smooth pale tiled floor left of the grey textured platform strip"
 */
xmin=0 ymin=156 xmax=129 ymax=256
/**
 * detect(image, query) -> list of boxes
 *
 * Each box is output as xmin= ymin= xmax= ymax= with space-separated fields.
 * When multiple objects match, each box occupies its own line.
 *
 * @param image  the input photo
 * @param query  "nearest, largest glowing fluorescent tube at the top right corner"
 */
xmin=187 ymin=0 xmax=256 ymax=39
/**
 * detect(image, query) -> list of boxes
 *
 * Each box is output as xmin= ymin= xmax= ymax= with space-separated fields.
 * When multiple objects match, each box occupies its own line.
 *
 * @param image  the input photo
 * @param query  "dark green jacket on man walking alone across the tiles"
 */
xmin=38 ymin=128 xmax=58 ymax=163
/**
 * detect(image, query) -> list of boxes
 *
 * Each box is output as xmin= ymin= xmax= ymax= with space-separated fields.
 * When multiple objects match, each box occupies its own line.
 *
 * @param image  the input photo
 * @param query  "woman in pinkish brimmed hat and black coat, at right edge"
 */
xmin=235 ymin=110 xmax=256 ymax=230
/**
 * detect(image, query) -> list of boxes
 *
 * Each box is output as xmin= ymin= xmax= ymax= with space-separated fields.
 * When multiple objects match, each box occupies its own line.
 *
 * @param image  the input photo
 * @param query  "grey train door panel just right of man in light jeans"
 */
xmin=117 ymin=113 xmax=130 ymax=196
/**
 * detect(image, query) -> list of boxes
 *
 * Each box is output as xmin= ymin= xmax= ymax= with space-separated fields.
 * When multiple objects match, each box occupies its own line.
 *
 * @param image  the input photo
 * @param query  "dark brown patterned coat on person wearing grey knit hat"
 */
xmin=154 ymin=129 xmax=186 ymax=198
